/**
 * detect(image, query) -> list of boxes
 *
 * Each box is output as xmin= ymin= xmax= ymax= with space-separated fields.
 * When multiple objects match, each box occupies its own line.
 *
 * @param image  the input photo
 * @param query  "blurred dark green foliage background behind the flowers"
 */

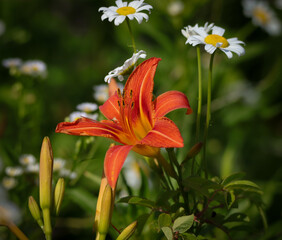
xmin=0 ymin=0 xmax=282 ymax=239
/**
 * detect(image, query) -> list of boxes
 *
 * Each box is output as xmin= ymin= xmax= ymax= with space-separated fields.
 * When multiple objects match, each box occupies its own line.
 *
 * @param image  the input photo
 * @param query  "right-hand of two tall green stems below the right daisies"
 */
xmin=202 ymin=52 xmax=215 ymax=179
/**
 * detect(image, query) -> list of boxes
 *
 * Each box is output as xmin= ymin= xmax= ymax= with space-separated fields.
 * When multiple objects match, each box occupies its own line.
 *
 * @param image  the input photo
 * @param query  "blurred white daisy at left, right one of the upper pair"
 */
xmin=20 ymin=60 xmax=47 ymax=77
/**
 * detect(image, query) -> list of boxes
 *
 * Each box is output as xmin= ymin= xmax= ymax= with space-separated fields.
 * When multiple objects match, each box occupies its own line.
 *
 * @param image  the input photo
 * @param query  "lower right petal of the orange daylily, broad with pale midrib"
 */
xmin=138 ymin=117 xmax=184 ymax=148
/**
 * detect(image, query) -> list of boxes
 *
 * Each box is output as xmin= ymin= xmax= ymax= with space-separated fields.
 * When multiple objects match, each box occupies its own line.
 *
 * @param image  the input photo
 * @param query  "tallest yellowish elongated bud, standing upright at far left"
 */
xmin=39 ymin=137 xmax=53 ymax=210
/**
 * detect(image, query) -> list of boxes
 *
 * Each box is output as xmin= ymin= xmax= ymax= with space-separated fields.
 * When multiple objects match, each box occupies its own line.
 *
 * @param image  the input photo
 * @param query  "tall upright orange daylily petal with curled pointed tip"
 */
xmin=124 ymin=58 xmax=161 ymax=135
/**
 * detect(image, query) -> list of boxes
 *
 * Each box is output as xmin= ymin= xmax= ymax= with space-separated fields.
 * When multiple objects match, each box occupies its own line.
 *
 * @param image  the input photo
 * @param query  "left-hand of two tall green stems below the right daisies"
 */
xmin=191 ymin=47 xmax=202 ymax=175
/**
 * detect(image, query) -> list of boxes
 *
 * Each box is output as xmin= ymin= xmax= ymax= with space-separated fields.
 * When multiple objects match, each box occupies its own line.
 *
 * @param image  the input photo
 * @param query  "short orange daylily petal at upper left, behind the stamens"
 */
xmin=99 ymin=94 xmax=120 ymax=122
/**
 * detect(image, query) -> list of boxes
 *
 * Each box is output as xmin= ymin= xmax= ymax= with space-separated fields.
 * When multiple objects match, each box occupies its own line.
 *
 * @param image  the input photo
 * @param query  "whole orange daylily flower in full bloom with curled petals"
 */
xmin=56 ymin=58 xmax=192 ymax=187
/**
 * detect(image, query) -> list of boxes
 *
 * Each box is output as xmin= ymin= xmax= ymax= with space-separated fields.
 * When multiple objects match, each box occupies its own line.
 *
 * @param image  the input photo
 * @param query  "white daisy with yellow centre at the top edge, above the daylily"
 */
xmin=98 ymin=0 xmax=153 ymax=26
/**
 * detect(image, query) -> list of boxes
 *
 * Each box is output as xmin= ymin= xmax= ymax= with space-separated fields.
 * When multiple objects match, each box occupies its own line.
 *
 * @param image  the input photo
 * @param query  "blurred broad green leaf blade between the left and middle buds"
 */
xmin=66 ymin=188 xmax=97 ymax=212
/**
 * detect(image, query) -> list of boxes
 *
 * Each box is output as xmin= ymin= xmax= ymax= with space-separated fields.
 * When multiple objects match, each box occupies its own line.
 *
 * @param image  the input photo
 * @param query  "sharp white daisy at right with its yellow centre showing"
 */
xmin=187 ymin=26 xmax=245 ymax=58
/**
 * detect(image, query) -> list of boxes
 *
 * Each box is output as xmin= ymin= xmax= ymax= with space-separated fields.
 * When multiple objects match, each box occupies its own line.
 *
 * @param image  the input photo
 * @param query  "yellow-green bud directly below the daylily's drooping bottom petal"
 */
xmin=98 ymin=184 xmax=112 ymax=236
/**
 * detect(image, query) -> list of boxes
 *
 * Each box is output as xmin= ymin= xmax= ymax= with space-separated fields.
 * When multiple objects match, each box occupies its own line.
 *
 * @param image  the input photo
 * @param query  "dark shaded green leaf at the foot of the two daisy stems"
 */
xmin=183 ymin=177 xmax=222 ymax=197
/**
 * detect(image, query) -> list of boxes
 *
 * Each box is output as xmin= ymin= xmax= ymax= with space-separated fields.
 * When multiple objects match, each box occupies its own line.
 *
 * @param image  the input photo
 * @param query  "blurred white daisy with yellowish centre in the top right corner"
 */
xmin=242 ymin=0 xmax=281 ymax=35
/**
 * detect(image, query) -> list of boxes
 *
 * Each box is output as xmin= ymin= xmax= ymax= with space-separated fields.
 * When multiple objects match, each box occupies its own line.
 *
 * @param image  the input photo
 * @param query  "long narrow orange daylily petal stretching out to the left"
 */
xmin=56 ymin=118 xmax=124 ymax=143
